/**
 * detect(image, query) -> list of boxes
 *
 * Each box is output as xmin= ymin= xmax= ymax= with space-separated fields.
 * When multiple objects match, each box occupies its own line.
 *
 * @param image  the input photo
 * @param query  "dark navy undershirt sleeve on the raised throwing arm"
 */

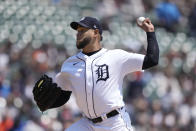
xmin=142 ymin=32 xmax=159 ymax=69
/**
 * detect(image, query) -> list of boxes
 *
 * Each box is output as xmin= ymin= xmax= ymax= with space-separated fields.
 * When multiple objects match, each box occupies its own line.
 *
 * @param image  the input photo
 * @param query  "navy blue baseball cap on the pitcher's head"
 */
xmin=70 ymin=17 xmax=102 ymax=35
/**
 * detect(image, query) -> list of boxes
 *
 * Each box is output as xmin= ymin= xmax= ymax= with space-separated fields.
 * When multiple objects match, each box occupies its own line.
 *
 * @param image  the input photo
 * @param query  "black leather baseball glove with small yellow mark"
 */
xmin=33 ymin=75 xmax=61 ymax=112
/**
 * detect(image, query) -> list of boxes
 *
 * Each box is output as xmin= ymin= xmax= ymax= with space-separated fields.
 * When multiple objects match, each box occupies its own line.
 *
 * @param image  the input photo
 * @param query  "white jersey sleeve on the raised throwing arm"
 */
xmin=118 ymin=50 xmax=145 ymax=75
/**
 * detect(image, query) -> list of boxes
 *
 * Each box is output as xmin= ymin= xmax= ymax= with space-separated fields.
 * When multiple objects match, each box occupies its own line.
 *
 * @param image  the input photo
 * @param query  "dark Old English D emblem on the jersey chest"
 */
xmin=95 ymin=64 xmax=109 ymax=83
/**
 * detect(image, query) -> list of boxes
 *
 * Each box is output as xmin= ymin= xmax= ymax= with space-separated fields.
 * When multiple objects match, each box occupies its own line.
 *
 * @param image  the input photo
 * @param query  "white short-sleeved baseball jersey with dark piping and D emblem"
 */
xmin=56 ymin=48 xmax=144 ymax=118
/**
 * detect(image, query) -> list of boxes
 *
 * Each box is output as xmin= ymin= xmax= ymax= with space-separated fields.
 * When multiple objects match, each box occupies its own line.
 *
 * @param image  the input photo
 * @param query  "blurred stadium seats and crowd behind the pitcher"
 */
xmin=0 ymin=0 xmax=196 ymax=131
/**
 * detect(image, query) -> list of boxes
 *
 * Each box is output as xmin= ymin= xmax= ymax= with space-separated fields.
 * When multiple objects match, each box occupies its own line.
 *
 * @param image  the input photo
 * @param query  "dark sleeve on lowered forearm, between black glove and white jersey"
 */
xmin=50 ymin=90 xmax=72 ymax=108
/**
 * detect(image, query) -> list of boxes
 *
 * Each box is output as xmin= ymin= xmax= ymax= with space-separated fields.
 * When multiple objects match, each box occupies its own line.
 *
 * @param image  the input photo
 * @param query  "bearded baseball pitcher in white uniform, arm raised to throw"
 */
xmin=33 ymin=17 xmax=159 ymax=131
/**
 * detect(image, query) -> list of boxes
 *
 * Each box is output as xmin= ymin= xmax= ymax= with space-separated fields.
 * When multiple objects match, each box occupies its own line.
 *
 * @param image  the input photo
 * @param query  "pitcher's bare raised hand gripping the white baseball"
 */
xmin=137 ymin=18 xmax=154 ymax=32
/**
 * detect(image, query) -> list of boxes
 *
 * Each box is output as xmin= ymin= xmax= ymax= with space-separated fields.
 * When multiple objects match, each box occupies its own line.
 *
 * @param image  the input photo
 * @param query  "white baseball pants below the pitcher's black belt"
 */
xmin=65 ymin=108 xmax=133 ymax=131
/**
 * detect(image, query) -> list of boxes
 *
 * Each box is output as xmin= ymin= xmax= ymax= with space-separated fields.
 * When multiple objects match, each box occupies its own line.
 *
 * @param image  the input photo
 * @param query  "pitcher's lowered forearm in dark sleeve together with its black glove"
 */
xmin=33 ymin=75 xmax=71 ymax=112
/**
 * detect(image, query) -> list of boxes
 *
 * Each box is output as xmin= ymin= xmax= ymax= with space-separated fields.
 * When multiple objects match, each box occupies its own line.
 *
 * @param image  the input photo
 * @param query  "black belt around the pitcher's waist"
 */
xmin=88 ymin=107 xmax=123 ymax=123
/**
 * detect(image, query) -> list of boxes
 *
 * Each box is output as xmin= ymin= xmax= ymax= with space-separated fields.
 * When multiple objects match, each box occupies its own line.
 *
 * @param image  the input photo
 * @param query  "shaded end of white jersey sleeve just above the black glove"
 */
xmin=55 ymin=72 xmax=72 ymax=91
